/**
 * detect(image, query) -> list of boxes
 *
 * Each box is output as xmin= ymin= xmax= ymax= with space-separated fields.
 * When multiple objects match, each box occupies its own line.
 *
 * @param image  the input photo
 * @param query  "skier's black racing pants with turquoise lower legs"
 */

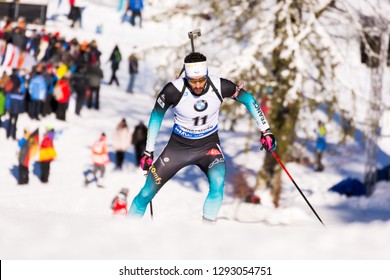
xmin=129 ymin=132 xmax=226 ymax=220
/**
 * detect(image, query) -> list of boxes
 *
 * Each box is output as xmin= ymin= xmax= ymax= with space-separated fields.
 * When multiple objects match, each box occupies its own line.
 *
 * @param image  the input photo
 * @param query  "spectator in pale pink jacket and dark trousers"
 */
xmin=113 ymin=119 xmax=131 ymax=170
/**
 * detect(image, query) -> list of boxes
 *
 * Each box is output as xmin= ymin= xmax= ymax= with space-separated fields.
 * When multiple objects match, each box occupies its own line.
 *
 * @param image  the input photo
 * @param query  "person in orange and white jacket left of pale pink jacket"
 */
xmin=92 ymin=133 xmax=110 ymax=188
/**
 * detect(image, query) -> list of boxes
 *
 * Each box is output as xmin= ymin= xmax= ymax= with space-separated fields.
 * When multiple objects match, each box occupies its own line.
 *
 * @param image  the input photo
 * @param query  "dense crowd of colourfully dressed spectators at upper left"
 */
xmin=0 ymin=14 xmax=103 ymax=139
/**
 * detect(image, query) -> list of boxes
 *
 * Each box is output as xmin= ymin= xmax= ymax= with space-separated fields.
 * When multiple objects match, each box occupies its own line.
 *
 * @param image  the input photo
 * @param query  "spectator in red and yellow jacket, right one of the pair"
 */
xmin=38 ymin=127 xmax=57 ymax=183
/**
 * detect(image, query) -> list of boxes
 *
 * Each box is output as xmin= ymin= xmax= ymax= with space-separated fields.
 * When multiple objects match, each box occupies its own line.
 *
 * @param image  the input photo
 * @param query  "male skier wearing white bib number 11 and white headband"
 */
xmin=129 ymin=52 xmax=276 ymax=222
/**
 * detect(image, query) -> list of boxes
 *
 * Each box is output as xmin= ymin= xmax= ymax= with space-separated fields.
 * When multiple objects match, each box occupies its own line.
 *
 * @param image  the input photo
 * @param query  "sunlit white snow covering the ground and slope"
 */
xmin=0 ymin=0 xmax=390 ymax=270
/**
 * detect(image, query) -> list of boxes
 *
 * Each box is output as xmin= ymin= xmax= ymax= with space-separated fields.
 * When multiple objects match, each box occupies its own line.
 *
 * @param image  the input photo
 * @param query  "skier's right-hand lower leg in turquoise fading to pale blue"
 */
xmin=203 ymin=162 xmax=226 ymax=221
